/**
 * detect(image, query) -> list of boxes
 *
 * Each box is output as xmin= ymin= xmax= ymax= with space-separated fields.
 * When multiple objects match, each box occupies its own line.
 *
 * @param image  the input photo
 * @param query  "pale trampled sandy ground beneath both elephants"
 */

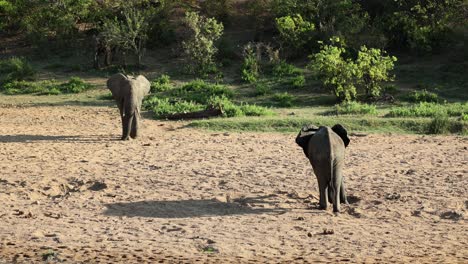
xmin=0 ymin=106 xmax=468 ymax=263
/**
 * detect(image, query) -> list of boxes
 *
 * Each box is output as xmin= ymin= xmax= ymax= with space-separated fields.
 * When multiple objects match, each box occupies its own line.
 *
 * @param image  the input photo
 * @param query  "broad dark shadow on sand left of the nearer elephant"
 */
xmin=104 ymin=196 xmax=286 ymax=218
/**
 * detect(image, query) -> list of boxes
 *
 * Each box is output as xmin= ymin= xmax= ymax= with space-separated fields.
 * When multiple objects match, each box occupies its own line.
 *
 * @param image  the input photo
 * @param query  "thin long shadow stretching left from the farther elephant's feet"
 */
xmin=0 ymin=135 xmax=119 ymax=143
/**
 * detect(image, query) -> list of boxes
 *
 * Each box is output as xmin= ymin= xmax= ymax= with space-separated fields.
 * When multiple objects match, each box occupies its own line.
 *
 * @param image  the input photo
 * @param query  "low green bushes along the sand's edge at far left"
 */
xmin=3 ymin=77 xmax=92 ymax=95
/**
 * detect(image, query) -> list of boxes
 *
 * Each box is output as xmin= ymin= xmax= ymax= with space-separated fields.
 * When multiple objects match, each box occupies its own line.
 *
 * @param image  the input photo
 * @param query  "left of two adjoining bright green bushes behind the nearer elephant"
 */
xmin=309 ymin=39 xmax=362 ymax=101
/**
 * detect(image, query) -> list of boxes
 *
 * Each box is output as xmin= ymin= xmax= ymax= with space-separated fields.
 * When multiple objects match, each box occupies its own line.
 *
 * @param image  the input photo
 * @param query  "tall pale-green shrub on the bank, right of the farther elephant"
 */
xmin=182 ymin=12 xmax=224 ymax=75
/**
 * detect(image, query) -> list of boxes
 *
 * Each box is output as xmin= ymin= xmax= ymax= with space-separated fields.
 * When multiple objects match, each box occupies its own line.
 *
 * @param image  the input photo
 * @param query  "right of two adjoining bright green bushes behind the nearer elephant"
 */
xmin=356 ymin=46 xmax=397 ymax=98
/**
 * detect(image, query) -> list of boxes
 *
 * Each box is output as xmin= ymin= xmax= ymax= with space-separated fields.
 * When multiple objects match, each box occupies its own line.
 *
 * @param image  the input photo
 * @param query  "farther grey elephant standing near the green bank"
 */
xmin=107 ymin=73 xmax=150 ymax=140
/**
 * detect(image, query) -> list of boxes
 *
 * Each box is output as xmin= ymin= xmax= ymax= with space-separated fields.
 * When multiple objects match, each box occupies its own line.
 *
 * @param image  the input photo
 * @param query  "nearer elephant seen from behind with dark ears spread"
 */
xmin=296 ymin=124 xmax=350 ymax=212
